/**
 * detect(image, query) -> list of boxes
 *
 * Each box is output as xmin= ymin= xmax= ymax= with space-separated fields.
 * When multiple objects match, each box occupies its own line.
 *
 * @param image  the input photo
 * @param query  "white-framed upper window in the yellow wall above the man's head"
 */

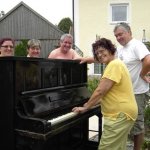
xmin=110 ymin=3 xmax=129 ymax=23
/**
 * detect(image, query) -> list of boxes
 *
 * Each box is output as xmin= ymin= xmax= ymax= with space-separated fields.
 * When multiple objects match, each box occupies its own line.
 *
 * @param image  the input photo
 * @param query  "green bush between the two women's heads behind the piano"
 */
xmin=15 ymin=40 xmax=28 ymax=56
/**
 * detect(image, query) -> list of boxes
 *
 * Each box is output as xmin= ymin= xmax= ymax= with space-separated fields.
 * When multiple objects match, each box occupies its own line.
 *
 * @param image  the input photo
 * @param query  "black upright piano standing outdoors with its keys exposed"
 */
xmin=0 ymin=57 xmax=102 ymax=150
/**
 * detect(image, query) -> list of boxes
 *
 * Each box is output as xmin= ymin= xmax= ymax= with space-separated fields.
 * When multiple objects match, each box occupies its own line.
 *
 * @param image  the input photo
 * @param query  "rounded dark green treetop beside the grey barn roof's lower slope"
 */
xmin=58 ymin=18 xmax=72 ymax=33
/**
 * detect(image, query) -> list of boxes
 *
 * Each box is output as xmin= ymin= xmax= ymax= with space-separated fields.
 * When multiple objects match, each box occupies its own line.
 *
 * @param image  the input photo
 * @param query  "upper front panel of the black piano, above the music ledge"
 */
xmin=15 ymin=60 xmax=87 ymax=92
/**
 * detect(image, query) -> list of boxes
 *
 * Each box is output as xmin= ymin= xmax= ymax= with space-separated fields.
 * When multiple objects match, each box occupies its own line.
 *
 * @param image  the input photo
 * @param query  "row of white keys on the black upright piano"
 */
xmin=48 ymin=112 xmax=78 ymax=126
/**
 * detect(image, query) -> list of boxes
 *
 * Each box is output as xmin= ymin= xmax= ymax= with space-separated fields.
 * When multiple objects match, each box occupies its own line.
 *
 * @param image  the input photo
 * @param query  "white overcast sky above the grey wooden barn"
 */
xmin=0 ymin=0 xmax=72 ymax=25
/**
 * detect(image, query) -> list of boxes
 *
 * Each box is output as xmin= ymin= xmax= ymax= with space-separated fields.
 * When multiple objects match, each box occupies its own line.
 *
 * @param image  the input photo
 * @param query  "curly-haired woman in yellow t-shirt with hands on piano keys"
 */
xmin=73 ymin=38 xmax=138 ymax=150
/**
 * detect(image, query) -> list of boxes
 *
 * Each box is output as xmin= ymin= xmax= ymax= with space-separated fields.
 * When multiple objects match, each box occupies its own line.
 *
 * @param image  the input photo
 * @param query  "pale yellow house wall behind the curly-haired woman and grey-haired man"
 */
xmin=74 ymin=0 xmax=150 ymax=74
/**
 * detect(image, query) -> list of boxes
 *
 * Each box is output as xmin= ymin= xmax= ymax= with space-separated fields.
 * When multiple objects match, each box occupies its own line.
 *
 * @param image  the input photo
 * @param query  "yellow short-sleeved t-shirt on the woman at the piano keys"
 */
xmin=101 ymin=59 xmax=137 ymax=120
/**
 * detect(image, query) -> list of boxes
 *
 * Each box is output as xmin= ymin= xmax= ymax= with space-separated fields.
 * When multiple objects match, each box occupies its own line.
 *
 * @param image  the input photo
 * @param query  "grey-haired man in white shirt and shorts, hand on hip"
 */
xmin=114 ymin=23 xmax=150 ymax=150
